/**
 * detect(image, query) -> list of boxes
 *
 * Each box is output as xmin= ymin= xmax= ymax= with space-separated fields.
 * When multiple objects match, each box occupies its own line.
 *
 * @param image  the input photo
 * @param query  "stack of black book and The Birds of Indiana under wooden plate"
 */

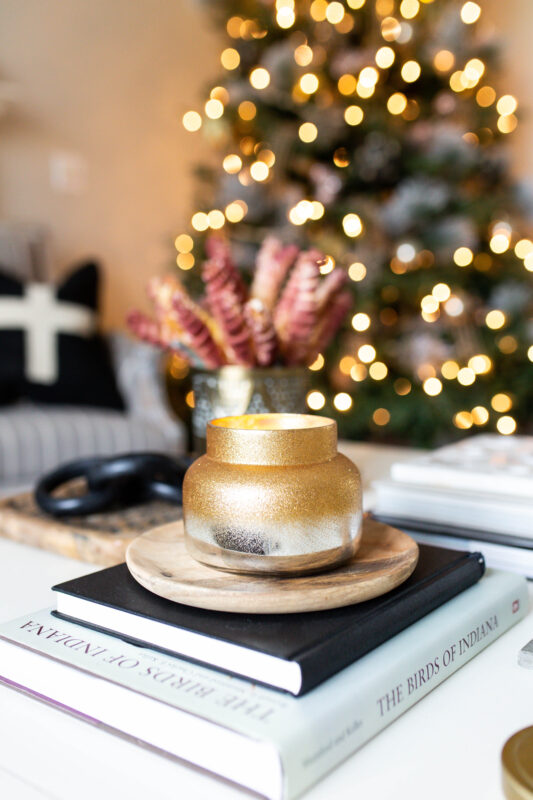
xmin=0 ymin=545 xmax=527 ymax=800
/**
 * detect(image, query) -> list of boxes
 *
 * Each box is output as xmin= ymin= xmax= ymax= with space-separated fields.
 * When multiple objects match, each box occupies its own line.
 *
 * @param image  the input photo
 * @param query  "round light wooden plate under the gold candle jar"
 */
xmin=126 ymin=518 xmax=418 ymax=614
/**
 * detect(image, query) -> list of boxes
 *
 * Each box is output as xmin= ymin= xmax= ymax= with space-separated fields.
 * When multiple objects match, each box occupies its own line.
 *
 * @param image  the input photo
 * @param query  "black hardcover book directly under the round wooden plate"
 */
xmin=53 ymin=545 xmax=485 ymax=695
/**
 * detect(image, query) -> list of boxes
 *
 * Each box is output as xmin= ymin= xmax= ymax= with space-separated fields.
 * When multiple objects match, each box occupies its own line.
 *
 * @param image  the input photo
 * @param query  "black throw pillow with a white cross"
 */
xmin=0 ymin=263 xmax=124 ymax=409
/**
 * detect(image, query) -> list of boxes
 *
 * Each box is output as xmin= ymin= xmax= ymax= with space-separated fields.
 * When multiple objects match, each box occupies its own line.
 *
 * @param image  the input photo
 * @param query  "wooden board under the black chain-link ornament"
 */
xmin=0 ymin=492 xmax=181 ymax=567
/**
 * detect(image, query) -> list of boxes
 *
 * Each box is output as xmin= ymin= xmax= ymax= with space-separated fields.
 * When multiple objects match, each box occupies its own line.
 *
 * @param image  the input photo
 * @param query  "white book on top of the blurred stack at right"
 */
xmin=391 ymin=434 xmax=533 ymax=501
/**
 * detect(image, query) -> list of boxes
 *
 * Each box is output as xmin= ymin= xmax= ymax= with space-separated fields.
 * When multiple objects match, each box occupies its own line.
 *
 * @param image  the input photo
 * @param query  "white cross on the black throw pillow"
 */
xmin=0 ymin=283 xmax=96 ymax=384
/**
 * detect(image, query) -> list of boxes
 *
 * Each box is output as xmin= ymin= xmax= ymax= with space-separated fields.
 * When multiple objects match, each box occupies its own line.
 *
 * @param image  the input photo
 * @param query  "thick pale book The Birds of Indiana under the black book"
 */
xmin=0 ymin=571 xmax=528 ymax=800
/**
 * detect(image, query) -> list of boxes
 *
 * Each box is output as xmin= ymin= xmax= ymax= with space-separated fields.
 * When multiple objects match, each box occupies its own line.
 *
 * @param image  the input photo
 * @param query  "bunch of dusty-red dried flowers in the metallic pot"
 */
xmin=128 ymin=237 xmax=351 ymax=369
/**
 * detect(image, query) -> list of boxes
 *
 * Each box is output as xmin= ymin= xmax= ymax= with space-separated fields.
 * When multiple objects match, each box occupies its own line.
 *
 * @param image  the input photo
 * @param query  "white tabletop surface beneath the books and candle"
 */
xmin=0 ymin=445 xmax=533 ymax=800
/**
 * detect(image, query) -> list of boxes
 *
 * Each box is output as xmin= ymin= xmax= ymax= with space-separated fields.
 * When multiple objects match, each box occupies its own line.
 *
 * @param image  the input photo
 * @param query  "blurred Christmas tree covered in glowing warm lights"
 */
xmin=172 ymin=0 xmax=533 ymax=445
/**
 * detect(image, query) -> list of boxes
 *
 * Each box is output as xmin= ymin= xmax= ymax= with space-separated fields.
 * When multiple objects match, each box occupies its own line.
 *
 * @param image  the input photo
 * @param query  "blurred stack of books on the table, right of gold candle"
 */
xmin=372 ymin=434 xmax=533 ymax=578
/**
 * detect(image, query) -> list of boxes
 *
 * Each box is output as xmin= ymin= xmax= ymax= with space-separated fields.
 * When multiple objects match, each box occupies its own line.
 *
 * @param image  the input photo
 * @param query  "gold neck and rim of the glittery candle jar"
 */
xmin=207 ymin=414 xmax=337 ymax=466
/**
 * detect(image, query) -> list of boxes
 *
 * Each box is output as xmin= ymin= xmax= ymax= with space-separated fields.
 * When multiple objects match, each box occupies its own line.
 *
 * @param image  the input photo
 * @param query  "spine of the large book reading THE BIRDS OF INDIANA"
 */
xmin=281 ymin=573 xmax=528 ymax=798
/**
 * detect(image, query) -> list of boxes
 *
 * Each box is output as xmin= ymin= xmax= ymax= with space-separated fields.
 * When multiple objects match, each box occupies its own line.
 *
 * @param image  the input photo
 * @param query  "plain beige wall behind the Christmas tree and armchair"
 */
xmin=0 ymin=0 xmax=533 ymax=326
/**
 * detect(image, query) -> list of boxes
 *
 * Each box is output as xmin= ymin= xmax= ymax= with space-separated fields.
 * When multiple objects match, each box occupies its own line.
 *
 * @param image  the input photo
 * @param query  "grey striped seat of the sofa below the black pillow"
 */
xmin=0 ymin=403 xmax=184 ymax=484
